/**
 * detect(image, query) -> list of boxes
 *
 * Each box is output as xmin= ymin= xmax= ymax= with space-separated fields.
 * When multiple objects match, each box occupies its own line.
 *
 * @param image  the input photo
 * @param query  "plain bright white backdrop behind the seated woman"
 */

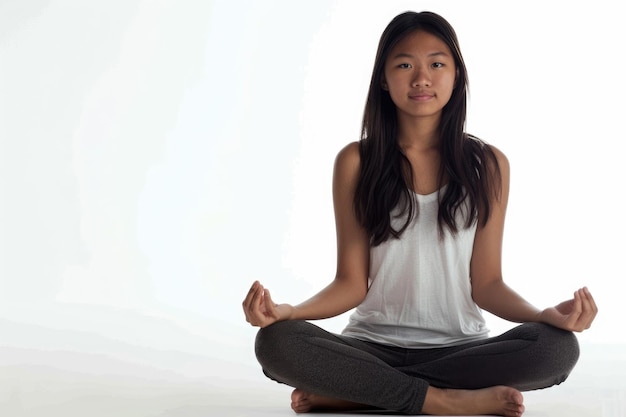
xmin=0 ymin=0 xmax=626 ymax=400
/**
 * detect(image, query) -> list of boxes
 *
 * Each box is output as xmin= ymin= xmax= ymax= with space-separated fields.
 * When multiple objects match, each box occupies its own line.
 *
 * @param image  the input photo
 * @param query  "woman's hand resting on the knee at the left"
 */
xmin=243 ymin=281 xmax=293 ymax=327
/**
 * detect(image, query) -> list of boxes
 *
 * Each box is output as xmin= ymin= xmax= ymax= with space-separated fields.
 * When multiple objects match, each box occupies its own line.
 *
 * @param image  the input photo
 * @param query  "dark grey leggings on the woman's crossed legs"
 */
xmin=255 ymin=321 xmax=579 ymax=414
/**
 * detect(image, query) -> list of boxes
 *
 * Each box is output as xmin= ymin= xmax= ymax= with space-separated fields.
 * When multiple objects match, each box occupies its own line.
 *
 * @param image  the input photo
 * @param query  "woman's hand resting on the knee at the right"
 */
xmin=540 ymin=287 xmax=598 ymax=332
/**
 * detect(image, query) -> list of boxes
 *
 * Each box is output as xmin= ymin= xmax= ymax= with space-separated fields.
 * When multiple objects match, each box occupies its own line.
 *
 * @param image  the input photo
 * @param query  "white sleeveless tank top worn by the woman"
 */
xmin=342 ymin=187 xmax=489 ymax=348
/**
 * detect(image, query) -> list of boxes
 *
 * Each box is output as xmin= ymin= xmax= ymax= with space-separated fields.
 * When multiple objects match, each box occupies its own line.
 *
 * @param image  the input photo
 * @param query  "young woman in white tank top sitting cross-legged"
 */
xmin=243 ymin=12 xmax=597 ymax=416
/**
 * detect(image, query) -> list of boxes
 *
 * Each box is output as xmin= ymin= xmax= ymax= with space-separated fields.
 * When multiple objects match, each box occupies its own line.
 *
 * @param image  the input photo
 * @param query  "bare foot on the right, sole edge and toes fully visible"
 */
xmin=422 ymin=386 xmax=524 ymax=417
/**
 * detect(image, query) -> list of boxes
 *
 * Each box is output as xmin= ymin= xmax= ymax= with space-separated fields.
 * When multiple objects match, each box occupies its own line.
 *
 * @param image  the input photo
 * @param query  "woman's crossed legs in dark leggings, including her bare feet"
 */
xmin=256 ymin=322 xmax=578 ymax=417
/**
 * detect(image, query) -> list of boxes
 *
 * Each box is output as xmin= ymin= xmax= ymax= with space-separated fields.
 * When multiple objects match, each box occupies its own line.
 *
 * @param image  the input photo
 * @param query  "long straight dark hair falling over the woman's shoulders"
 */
xmin=354 ymin=12 xmax=500 ymax=246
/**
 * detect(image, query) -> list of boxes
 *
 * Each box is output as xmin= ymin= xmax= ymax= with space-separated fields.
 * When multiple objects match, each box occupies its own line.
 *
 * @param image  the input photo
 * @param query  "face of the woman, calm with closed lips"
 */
xmin=382 ymin=30 xmax=456 ymax=119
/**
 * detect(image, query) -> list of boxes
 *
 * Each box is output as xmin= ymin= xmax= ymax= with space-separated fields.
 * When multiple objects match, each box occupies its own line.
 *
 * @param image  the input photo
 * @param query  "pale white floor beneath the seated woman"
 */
xmin=0 ymin=304 xmax=626 ymax=417
